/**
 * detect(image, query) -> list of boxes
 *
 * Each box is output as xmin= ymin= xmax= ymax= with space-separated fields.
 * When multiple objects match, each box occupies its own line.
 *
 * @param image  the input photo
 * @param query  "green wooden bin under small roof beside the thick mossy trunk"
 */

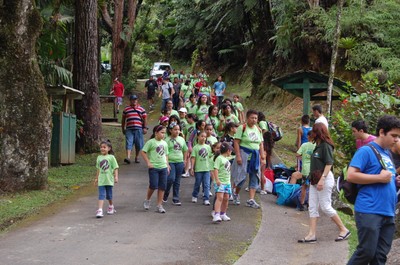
xmin=50 ymin=112 xmax=76 ymax=166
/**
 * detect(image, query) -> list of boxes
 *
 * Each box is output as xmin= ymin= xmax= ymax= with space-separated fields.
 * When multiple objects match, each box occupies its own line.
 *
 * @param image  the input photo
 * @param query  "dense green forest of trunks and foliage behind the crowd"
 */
xmin=0 ymin=0 xmax=400 ymax=236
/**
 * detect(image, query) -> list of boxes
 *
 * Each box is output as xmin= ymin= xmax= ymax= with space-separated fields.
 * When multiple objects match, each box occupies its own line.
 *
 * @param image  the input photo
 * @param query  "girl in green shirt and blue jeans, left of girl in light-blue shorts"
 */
xmin=190 ymin=131 xmax=211 ymax=205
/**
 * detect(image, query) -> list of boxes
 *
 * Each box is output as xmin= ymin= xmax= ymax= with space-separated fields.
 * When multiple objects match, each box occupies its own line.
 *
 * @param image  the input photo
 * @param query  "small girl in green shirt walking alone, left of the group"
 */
xmin=95 ymin=141 xmax=119 ymax=218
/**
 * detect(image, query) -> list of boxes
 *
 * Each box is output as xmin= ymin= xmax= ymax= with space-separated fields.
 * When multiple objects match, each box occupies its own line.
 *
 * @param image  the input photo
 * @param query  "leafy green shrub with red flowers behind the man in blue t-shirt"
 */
xmin=332 ymin=77 xmax=400 ymax=168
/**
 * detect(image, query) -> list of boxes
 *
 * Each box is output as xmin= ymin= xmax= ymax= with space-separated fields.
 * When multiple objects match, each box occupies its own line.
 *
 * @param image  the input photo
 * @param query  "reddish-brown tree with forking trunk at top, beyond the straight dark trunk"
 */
xmin=100 ymin=0 xmax=142 ymax=80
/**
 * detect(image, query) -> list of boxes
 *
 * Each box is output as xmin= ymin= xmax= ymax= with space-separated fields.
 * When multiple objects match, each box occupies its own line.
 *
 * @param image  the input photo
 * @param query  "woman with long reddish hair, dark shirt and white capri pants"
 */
xmin=298 ymin=123 xmax=350 ymax=243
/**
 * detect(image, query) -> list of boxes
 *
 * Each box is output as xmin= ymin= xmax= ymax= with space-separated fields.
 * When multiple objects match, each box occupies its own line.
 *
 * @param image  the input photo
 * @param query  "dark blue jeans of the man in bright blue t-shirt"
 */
xmin=347 ymin=212 xmax=395 ymax=265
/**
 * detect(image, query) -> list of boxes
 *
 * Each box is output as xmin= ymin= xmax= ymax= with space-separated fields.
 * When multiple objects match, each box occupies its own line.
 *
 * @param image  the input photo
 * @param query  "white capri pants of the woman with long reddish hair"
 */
xmin=308 ymin=172 xmax=336 ymax=217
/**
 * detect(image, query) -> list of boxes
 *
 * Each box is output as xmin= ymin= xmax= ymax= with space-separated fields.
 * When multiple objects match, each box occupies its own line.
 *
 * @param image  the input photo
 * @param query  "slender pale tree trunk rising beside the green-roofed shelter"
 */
xmin=326 ymin=0 xmax=344 ymax=117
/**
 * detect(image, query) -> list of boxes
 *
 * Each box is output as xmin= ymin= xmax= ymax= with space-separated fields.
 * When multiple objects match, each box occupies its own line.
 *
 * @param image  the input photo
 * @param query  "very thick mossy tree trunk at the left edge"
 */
xmin=0 ymin=0 xmax=51 ymax=192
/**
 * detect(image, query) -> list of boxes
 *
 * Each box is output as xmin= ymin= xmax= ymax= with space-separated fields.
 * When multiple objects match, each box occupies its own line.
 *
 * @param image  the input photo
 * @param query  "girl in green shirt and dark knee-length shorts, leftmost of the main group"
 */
xmin=141 ymin=125 xmax=170 ymax=213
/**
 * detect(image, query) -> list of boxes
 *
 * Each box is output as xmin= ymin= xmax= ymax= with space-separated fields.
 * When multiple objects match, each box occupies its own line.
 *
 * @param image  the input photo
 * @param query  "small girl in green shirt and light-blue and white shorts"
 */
xmin=213 ymin=142 xmax=233 ymax=223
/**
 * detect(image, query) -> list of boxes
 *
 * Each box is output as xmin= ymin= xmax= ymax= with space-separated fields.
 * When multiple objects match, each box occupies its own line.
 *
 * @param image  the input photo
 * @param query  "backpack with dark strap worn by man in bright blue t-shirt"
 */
xmin=336 ymin=144 xmax=386 ymax=204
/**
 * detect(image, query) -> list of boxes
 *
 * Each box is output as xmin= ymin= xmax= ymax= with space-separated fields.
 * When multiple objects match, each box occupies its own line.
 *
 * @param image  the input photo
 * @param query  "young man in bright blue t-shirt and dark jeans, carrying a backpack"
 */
xmin=347 ymin=115 xmax=400 ymax=265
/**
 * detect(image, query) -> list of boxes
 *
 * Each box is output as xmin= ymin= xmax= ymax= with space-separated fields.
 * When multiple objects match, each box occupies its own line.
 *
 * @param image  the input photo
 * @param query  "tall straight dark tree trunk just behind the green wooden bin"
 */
xmin=74 ymin=0 xmax=101 ymax=152
